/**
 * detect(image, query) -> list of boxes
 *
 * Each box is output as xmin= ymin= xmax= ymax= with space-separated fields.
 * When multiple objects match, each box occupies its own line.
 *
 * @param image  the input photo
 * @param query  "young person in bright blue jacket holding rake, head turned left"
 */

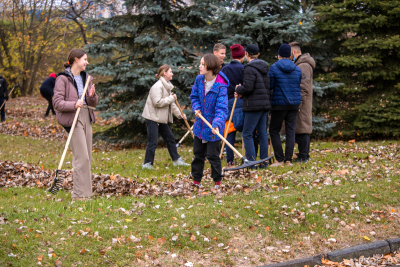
xmin=190 ymin=54 xmax=229 ymax=188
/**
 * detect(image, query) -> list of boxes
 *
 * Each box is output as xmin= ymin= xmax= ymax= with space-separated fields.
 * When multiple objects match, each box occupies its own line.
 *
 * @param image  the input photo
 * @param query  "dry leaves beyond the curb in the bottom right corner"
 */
xmin=315 ymin=253 xmax=400 ymax=267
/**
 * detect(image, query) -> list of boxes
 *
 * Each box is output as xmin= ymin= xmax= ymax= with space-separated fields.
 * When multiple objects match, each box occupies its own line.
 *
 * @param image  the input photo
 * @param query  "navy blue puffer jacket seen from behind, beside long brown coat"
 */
xmin=268 ymin=59 xmax=301 ymax=110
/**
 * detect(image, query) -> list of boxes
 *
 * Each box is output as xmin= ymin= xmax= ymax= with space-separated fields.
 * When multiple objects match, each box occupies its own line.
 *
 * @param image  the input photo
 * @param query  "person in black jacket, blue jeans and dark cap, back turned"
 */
xmin=236 ymin=44 xmax=271 ymax=167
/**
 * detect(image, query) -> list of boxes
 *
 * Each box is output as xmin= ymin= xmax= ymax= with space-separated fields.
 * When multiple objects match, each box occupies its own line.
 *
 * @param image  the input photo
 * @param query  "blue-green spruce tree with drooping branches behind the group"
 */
xmin=87 ymin=0 xmax=314 ymax=142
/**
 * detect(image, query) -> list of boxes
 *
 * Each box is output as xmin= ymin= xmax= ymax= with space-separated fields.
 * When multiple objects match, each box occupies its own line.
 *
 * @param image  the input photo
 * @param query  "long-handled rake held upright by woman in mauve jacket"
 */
xmin=49 ymin=76 xmax=91 ymax=195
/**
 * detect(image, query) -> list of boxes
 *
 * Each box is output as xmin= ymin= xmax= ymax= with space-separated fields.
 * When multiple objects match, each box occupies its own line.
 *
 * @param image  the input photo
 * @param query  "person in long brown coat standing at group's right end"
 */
xmin=289 ymin=42 xmax=315 ymax=162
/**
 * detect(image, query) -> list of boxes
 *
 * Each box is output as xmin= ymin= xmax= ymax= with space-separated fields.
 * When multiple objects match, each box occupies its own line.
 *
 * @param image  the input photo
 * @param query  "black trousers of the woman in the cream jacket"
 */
xmin=144 ymin=120 xmax=179 ymax=165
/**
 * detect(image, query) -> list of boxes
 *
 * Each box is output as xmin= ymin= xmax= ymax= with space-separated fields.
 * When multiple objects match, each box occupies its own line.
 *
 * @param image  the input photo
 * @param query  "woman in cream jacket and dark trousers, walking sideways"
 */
xmin=142 ymin=65 xmax=190 ymax=169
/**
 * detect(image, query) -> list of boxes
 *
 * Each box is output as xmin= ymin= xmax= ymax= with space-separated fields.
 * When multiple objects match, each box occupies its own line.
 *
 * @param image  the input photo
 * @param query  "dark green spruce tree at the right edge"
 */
xmin=315 ymin=0 xmax=400 ymax=137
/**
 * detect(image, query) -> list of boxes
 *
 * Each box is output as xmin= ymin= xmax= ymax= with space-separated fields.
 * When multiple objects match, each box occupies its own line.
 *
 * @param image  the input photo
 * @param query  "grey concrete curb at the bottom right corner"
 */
xmin=259 ymin=237 xmax=400 ymax=267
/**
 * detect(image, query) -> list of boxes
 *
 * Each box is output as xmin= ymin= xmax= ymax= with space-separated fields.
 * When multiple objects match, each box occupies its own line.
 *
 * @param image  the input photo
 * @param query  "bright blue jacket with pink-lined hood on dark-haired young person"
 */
xmin=190 ymin=72 xmax=229 ymax=142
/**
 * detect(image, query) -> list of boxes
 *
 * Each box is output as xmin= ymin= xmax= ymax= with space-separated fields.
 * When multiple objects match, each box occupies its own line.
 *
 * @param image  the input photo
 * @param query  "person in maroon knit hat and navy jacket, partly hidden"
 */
xmin=221 ymin=44 xmax=244 ymax=165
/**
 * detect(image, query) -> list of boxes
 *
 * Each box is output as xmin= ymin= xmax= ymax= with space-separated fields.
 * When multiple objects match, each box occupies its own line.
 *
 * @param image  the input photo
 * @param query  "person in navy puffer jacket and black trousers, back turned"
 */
xmin=269 ymin=44 xmax=301 ymax=167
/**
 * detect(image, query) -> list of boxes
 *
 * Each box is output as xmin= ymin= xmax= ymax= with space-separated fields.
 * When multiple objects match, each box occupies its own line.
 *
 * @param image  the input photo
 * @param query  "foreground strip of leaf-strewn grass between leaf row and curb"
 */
xmin=0 ymin=171 xmax=400 ymax=266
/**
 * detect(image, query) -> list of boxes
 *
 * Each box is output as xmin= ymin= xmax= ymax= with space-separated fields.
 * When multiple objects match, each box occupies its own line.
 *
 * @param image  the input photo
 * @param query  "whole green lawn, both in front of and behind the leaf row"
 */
xmin=0 ymin=98 xmax=400 ymax=266
